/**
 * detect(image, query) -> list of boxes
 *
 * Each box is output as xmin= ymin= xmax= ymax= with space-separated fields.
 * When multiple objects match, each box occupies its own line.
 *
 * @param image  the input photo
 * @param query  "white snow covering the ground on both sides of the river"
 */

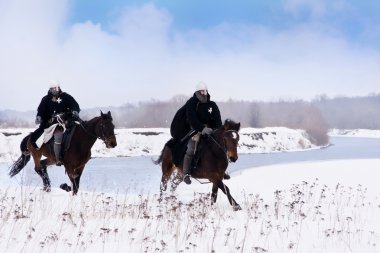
xmin=0 ymin=128 xmax=380 ymax=253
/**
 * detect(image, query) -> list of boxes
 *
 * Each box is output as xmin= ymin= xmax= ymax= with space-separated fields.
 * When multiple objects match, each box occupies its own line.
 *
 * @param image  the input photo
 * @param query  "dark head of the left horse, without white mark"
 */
xmin=96 ymin=111 xmax=117 ymax=148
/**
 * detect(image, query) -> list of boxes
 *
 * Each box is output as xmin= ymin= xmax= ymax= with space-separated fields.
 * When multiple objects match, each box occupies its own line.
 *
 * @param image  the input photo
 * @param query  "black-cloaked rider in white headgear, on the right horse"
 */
xmin=173 ymin=82 xmax=230 ymax=184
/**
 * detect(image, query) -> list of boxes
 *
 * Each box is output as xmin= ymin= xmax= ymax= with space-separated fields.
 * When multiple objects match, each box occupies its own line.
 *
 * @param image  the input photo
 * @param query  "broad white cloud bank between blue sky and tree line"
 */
xmin=0 ymin=0 xmax=380 ymax=110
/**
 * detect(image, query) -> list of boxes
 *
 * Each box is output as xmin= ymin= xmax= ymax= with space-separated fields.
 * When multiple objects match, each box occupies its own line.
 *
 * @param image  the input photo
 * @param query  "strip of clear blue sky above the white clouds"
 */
xmin=68 ymin=0 xmax=380 ymax=48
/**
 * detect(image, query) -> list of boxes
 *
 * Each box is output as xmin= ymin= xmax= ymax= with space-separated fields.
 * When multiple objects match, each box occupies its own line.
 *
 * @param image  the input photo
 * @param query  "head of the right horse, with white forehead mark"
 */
xmin=223 ymin=119 xmax=240 ymax=162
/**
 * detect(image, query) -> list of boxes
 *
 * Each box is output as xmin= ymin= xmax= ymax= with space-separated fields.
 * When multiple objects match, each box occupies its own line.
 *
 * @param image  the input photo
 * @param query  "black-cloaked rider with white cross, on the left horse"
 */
xmin=30 ymin=81 xmax=80 ymax=166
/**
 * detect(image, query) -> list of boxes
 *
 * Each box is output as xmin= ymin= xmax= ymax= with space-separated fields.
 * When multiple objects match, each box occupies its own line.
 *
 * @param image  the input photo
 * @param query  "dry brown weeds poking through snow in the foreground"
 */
xmin=0 ymin=180 xmax=380 ymax=252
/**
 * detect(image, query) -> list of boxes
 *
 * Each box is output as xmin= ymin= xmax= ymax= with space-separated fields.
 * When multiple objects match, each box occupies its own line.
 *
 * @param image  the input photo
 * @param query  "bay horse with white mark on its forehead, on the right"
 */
xmin=154 ymin=119 xmax=241 ymax=211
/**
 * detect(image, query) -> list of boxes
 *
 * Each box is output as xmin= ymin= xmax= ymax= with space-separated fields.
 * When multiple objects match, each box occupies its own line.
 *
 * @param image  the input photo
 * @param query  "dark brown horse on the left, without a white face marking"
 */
xmin=9 ymin=109 xmax=117 ymax=195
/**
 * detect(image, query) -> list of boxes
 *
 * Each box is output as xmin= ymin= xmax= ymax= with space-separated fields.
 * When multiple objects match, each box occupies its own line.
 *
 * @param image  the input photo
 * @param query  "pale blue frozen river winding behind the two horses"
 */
xmin=0 ymin=137 xmax=380 ymax=193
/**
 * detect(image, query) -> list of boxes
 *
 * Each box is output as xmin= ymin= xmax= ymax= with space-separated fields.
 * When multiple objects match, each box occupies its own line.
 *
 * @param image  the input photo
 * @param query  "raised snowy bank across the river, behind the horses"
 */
xmin=0 ymin=127 xmax=315 ymax=162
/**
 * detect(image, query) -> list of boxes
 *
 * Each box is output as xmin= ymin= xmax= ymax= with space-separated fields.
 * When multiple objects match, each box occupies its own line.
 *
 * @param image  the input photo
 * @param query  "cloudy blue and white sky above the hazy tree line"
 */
xmin=0 ymin=0 xmax=380 ymax=110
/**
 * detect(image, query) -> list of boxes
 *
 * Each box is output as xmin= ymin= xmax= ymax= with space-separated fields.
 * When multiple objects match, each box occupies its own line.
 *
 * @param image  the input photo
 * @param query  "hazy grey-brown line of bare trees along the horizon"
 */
xmin=0 ymin=94 xmax=380 ymax=145
